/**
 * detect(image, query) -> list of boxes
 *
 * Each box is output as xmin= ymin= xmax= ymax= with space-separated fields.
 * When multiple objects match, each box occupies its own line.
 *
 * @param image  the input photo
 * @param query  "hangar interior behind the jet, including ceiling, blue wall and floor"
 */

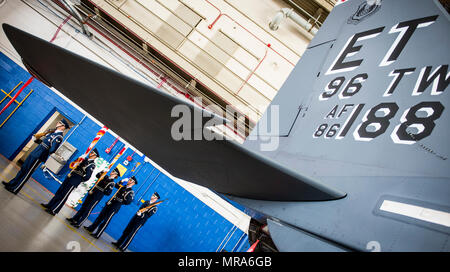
xmin=0 ymin=0 xmax=335 ymax=252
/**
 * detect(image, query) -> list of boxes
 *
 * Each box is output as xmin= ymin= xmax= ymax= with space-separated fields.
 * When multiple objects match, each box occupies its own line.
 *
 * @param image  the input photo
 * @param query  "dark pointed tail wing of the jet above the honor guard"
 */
xmin=3 ymin=24 xmax=345 ymax=201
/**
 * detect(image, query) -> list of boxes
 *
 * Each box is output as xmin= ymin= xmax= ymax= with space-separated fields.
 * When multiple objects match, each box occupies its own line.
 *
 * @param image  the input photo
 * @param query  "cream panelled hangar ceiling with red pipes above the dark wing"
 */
xmin=62 ymin=0 xmax=335 ymax=139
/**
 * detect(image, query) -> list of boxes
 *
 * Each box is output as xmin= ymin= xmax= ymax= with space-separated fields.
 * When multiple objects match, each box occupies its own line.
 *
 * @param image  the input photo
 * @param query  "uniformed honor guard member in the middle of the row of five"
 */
xmin=66 ymin=168 xmax=120 ymax=228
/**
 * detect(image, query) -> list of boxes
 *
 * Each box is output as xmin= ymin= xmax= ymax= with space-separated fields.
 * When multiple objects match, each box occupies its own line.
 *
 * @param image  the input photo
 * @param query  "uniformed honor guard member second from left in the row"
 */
xmin=41 ymin=148 xmax=99 ymax=215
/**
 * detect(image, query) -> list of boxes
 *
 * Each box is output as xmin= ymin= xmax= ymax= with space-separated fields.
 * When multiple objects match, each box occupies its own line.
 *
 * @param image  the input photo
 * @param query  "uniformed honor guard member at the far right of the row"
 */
xmin=112 ymin=192 xmax=159 ymax=251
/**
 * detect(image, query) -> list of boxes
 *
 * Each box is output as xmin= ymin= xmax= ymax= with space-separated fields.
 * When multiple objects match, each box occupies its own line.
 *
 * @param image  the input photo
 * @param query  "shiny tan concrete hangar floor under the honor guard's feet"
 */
xmin=0 ymin=155 xmax=117 ymax=252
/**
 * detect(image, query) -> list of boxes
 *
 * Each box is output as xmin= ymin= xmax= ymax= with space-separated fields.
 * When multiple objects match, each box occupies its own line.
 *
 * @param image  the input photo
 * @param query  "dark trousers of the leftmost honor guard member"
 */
xmin=6 ymin=149 xmax=44 ymax=194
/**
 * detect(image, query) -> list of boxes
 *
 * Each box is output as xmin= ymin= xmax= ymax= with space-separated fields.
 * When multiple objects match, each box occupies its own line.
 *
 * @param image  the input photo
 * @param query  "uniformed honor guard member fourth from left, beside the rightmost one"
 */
xmin=84 ymin=176 xmax=137 ymax=239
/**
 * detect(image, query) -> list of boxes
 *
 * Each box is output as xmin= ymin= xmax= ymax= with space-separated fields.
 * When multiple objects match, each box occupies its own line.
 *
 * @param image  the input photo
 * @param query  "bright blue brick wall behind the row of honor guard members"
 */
xmin=0 ymin=53 xmax=249 ymax=252
